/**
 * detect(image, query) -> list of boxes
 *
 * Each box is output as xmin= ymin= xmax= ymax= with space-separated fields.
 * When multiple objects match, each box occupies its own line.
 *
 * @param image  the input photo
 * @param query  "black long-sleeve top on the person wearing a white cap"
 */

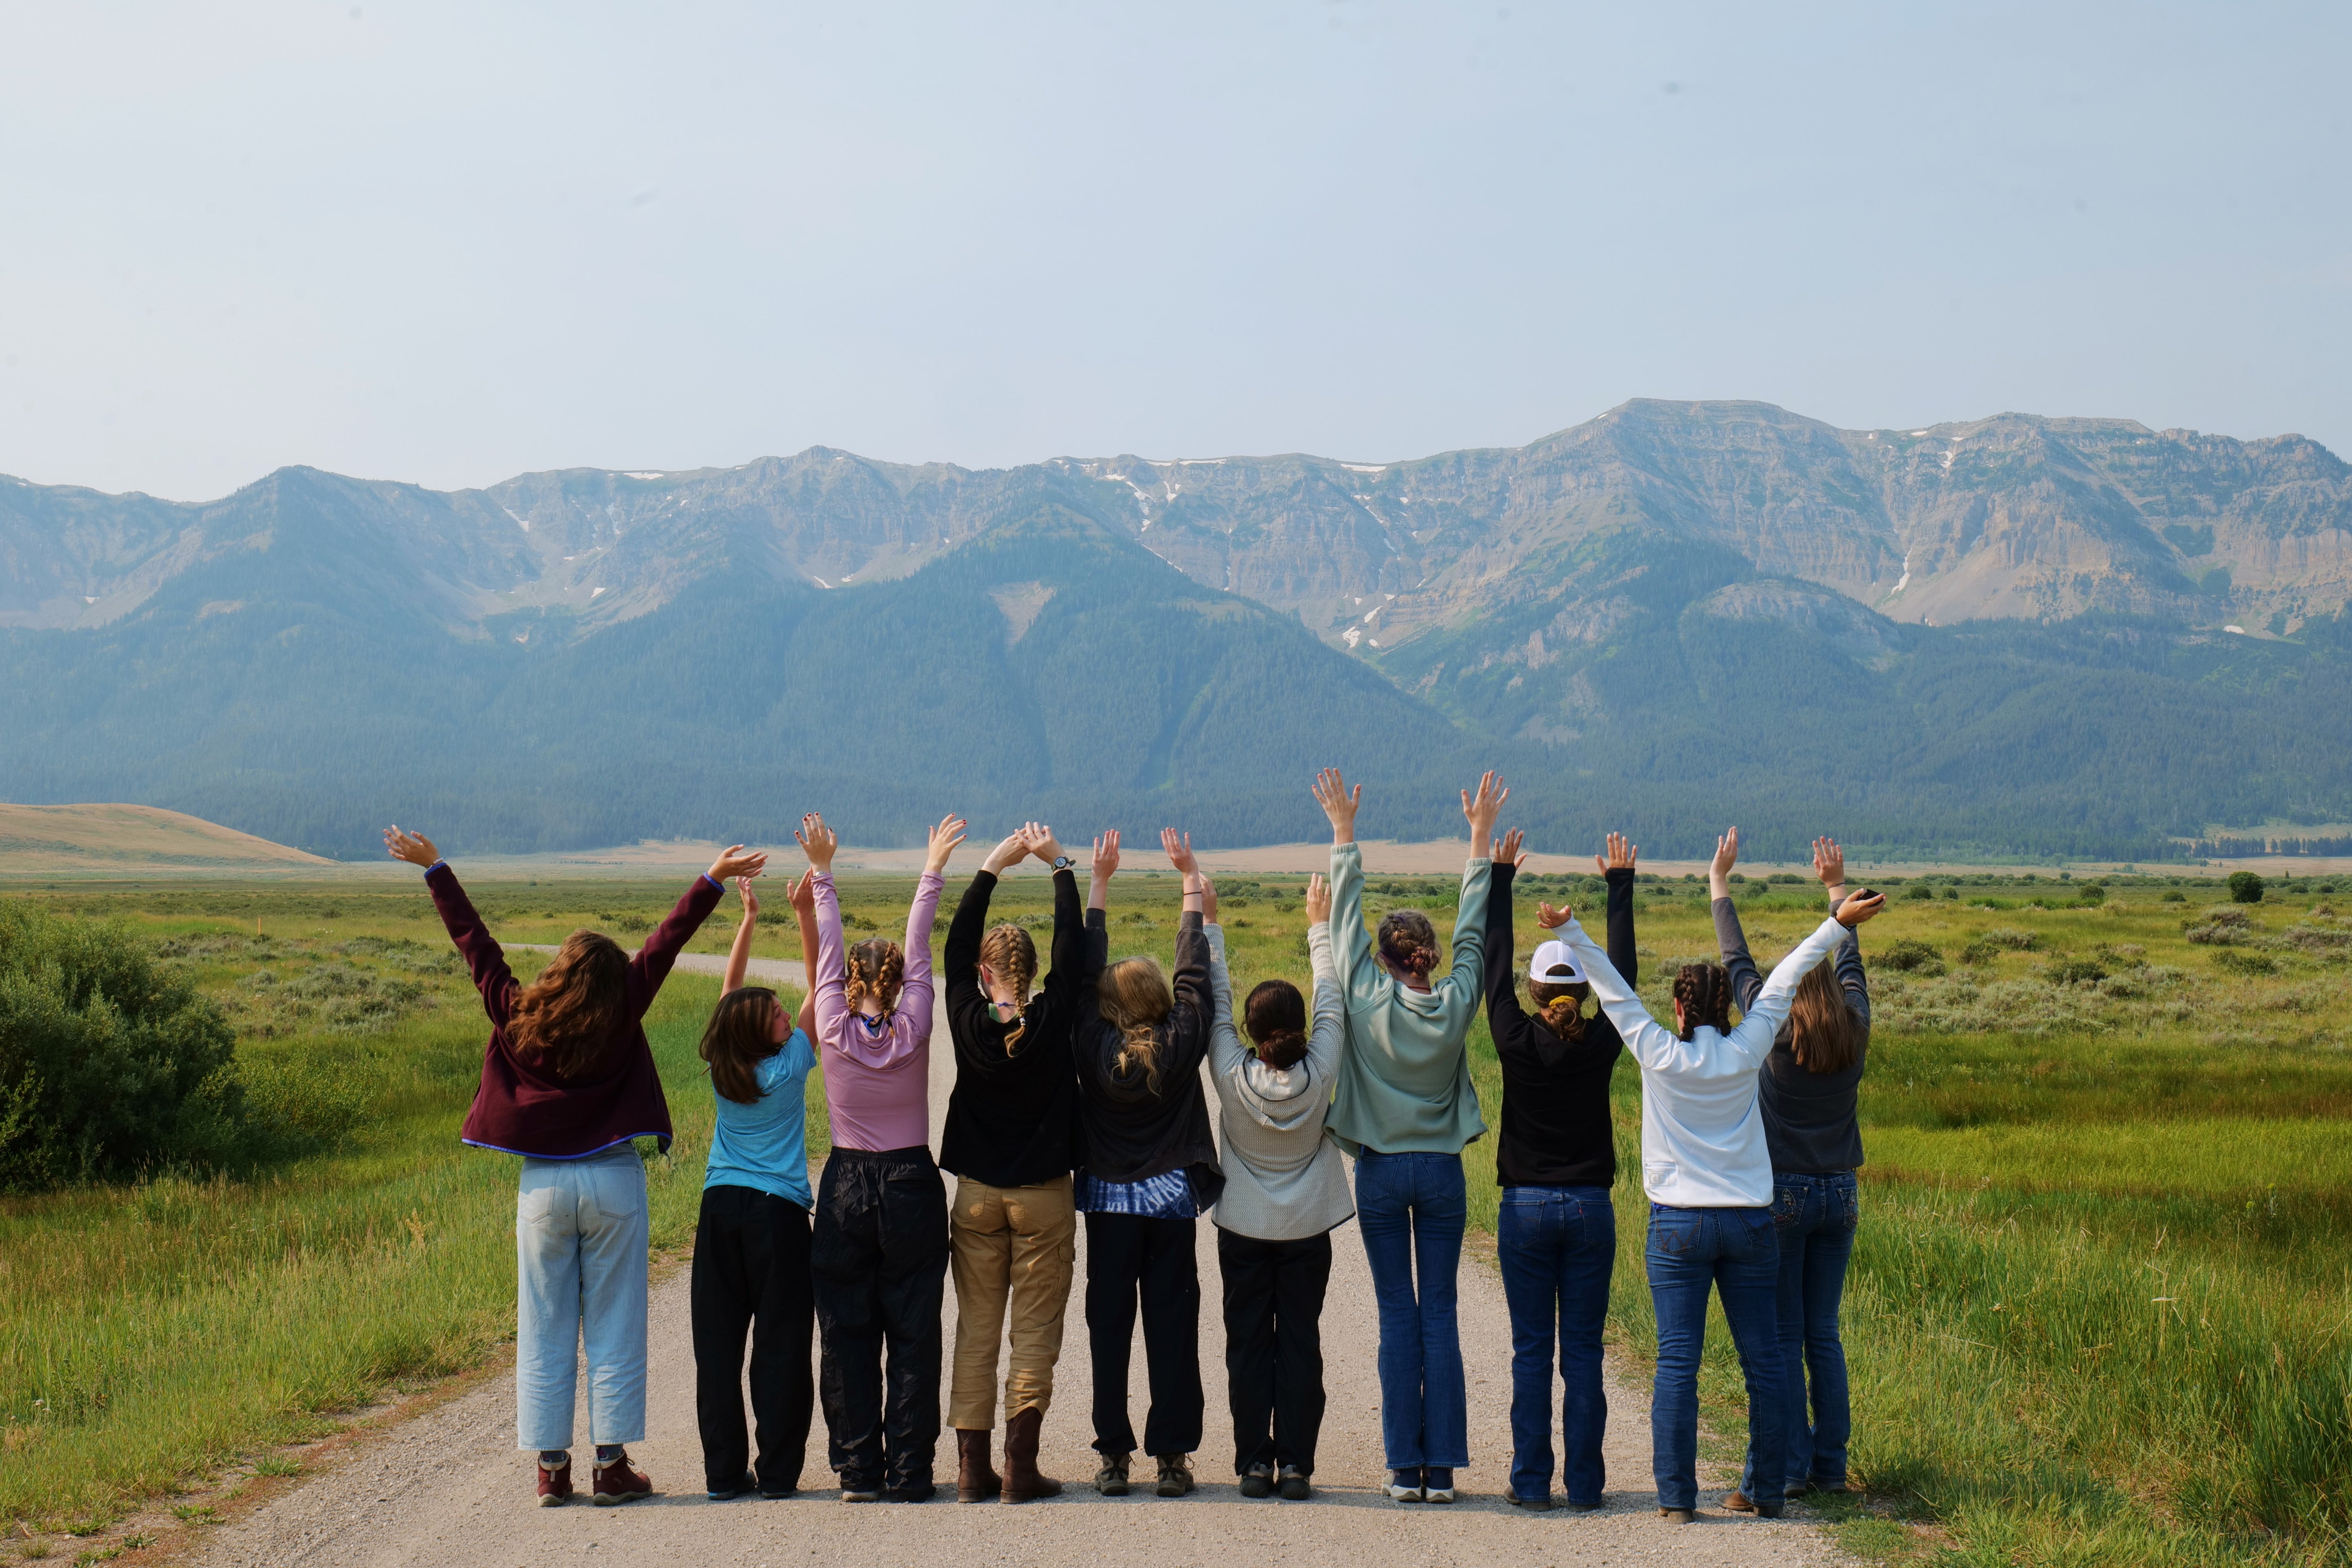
xmin=1486 ymin=860 xmax=1639 ymax=1187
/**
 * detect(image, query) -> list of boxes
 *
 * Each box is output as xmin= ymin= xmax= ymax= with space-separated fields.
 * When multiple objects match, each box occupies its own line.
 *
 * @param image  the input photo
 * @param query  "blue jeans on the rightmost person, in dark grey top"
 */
xmin=1740 ymin=1171 xmax=1863 ymax=1488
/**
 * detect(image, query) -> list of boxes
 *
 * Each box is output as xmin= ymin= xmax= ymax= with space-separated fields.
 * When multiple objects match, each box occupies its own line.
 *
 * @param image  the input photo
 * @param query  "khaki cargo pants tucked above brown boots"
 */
xmin=948 ymin=1176 xmax=1077 ymax=1432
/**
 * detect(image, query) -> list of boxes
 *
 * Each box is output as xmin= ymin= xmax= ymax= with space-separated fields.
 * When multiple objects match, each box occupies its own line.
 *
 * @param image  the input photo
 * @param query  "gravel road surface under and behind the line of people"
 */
xmin=191 ymin=954 xmax=1842 ymax=1568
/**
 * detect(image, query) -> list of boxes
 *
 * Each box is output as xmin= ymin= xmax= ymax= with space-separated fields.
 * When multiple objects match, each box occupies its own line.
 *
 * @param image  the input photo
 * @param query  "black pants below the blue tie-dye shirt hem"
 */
xmin=1087 ymin=1213 xmax=1202 ymax=1455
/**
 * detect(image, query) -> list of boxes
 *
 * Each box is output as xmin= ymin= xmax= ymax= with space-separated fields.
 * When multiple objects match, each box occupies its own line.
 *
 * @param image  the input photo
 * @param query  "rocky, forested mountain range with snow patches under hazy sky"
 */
xmin=0 ymin=402 xmax=2352 ymax=858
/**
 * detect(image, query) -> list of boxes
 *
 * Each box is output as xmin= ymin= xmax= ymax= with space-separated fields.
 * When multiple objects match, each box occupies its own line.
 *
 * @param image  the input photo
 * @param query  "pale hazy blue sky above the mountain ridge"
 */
xmin=0 ymin=0 xmax=2352 ymax=499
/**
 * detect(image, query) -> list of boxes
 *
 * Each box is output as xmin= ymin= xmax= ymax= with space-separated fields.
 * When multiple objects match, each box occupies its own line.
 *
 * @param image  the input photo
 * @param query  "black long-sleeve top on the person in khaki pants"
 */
xmin=938 ymin=870 xmax=1103 ymax=1187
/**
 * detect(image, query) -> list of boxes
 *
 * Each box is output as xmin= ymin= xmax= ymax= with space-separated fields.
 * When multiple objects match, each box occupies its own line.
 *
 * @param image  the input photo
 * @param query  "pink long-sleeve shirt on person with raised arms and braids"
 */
xmin=816 ymin=872 xmax=941 ymax=1152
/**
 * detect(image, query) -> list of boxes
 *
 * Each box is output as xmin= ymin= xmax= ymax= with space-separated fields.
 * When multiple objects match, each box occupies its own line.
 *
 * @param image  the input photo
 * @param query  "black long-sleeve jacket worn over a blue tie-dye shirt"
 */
xmin=1075 ymin=910 xmax=1225 ymax=1204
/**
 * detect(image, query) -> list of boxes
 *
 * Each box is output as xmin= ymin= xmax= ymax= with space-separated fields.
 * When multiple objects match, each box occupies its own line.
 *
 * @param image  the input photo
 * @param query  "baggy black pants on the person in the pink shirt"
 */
xmin=809 ymin=1145 xmax=948 ymax=1490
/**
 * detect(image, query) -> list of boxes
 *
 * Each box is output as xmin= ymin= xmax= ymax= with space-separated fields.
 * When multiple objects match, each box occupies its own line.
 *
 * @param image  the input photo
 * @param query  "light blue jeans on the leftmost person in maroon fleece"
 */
xmin=515 ymin=1143 xmax=647 ymax=1450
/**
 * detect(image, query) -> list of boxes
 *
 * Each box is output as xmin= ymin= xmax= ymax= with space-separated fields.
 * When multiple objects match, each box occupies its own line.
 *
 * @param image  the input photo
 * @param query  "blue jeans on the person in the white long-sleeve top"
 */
xmin=1644 ymin=1204 xmax=1788 ymax=1509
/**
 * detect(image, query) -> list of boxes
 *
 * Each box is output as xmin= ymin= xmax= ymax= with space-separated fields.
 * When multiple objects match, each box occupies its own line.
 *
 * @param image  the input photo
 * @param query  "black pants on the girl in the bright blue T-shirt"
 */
xmin=691 ymin=1187 xmax=816 ymax=1490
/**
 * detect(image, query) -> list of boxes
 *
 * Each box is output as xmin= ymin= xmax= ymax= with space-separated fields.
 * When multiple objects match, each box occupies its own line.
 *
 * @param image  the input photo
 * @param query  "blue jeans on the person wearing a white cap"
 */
xmin=1496 ymin=1187 xmax=1616 ymax=1507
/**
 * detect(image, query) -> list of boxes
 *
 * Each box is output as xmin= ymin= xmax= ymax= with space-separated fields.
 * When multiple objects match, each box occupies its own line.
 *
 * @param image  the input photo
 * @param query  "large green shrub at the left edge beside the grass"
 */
xmin=0 ymin=905 xmax=242 ymax=1192
